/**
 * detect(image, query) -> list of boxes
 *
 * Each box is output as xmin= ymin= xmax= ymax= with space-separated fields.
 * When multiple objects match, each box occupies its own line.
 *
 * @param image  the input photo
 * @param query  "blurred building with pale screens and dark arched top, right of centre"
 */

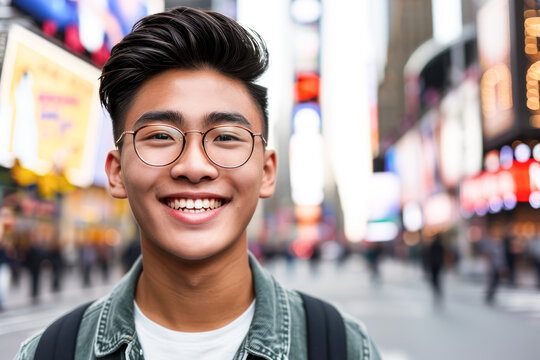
xmin=385 ymin=27 xmax=482 ymax=262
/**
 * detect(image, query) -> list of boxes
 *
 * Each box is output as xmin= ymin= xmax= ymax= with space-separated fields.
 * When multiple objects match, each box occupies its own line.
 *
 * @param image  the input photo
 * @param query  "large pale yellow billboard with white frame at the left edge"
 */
xmin=0 ymin=25 xmax=101 ymax=186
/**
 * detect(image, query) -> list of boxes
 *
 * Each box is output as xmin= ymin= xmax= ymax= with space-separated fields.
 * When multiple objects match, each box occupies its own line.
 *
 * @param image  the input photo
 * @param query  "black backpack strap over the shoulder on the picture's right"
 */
xmin=299 ymin=292 xmax=347 ymax=360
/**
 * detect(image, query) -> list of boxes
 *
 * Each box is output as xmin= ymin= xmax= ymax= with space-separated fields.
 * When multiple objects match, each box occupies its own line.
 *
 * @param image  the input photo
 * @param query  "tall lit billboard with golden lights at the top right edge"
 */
xmin=477 ymin=0 xmax=540 ymax=150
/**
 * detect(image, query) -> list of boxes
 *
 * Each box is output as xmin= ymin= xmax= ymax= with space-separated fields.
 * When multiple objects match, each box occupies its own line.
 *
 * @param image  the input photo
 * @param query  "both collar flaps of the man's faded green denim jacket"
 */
xmin=94 ymin=253 xmax=291 ymax=360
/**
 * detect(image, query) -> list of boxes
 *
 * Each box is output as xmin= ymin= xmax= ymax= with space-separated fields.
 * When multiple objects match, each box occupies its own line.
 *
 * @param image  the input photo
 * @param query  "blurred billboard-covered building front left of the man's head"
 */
xmin=0 ymin=0 xmax=164 ymax=257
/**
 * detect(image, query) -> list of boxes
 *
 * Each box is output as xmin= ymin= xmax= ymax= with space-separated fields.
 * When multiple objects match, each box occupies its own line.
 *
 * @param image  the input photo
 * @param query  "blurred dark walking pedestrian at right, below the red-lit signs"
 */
xmin=482 ymin=226 xmax=506 ymax=304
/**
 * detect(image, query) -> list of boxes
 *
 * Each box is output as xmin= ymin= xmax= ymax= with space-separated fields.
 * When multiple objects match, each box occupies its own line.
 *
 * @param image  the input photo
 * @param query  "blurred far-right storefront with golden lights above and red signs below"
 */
xmin=460 ymin=0 xmax=540 ymax=272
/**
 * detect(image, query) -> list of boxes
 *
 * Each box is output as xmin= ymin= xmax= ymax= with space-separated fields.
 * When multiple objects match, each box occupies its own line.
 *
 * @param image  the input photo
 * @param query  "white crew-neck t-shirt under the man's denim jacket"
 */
xmin=133 ymin=300 xmax=255 ymax=360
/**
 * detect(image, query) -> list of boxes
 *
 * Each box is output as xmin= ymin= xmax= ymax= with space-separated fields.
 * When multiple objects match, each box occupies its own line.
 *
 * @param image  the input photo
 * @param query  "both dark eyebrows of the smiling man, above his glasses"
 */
xmin=133 ymin=110 xmax=253 ymax=129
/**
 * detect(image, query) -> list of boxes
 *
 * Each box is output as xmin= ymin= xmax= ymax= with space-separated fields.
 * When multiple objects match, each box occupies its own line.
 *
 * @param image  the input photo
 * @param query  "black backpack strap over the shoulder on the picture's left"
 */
xmin=34 ymin=301 xmax=92 ymax=360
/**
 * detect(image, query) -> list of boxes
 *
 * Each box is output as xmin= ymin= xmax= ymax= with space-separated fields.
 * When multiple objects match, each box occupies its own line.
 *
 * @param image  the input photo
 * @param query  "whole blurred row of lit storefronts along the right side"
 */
xmin=385 ymin=0 xmax=540 ymax=276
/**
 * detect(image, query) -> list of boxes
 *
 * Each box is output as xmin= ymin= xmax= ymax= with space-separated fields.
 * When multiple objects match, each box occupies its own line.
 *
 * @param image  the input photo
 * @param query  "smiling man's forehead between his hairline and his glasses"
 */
xmin=124 ymin=69 xmax=262 ymax=131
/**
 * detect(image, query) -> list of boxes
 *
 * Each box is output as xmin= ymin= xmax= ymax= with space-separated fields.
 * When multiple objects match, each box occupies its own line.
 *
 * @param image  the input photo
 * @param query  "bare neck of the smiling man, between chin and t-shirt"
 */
xmin=135 ymin=239 xmax=255 ymax=332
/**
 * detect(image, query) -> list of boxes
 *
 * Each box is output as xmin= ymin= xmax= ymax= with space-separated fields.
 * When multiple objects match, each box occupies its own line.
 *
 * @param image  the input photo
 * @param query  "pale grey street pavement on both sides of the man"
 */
xmin=0 ymin=256 xmax=540 ymax=360
